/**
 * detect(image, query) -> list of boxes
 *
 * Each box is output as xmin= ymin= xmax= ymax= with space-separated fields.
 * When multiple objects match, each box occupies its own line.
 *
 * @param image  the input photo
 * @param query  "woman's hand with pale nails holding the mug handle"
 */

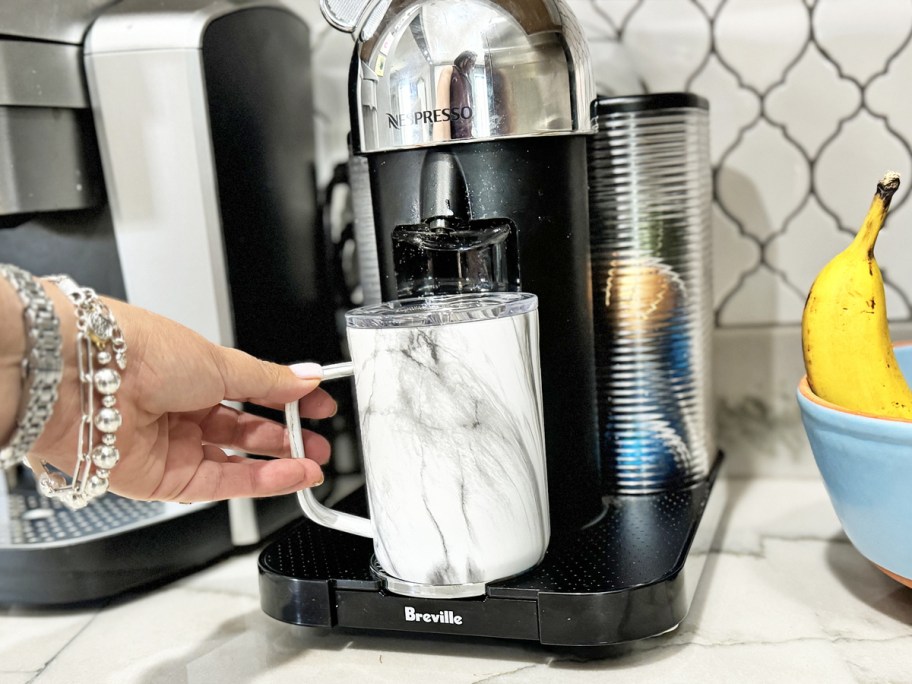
xmin=29 ymin=281 xmax=336 ymax=502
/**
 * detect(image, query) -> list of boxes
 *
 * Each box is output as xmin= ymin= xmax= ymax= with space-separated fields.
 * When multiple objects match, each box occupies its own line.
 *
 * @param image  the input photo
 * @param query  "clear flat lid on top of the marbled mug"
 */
xmin=345 ymin=292 xmax=538 ymax=328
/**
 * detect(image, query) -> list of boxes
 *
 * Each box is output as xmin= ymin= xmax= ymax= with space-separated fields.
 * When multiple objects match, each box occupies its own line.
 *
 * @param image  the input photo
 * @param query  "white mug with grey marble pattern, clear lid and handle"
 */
xmin=286 ymin=292 xmax=550 ymax=598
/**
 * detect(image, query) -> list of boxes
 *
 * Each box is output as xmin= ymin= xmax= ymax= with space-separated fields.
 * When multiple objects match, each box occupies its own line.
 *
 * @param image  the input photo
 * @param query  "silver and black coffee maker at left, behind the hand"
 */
xmin=0 ymin=0 xmax=341 ymax=604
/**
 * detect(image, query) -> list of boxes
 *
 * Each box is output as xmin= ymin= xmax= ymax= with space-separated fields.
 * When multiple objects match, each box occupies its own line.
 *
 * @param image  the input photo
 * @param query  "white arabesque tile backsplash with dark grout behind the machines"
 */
xmin=287 ymin=0 xmax=912 ymax=474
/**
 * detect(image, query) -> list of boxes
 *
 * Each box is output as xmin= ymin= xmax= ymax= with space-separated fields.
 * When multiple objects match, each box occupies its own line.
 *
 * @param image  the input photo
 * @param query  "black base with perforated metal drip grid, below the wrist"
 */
xmin=0 ymin=481 xmax=234 ymax=606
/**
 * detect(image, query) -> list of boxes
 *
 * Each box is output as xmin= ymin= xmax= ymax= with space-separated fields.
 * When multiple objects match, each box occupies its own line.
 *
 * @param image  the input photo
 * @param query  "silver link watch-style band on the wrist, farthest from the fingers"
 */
xmin=0 ymin=264 xmax=63 ymax=470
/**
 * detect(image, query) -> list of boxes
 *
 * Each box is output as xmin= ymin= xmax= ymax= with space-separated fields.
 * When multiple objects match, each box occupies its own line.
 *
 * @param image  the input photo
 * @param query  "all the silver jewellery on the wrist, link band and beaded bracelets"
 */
xmin=0 ymin=264 xmax=127 ymax=509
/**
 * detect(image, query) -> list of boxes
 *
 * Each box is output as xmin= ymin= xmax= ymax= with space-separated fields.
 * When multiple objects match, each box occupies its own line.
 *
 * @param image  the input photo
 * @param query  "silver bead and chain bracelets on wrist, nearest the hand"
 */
xmin=38 ymin=276 xmax=127 ymax=509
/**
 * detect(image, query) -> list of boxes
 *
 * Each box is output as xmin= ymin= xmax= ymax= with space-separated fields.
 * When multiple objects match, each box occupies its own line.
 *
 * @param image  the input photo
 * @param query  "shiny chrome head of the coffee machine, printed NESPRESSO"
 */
xmin=334 ymin=0 xmax=594 ymax=152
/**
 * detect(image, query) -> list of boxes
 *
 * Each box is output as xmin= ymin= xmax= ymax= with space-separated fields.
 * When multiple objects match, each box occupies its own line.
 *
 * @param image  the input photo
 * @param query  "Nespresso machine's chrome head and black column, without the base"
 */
xmin=349 ymin=1 xmax=601 ymax=528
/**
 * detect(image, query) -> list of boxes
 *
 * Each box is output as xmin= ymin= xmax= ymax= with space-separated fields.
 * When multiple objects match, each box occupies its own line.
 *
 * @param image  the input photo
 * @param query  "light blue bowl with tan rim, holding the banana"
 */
xmin=798 ymin=344 xmax=912 ymax=587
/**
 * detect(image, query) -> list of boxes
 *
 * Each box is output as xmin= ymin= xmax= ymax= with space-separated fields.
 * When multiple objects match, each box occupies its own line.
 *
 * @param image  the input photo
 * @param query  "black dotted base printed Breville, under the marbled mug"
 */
xmin=259 ymin=454 xmax=727 ymax=646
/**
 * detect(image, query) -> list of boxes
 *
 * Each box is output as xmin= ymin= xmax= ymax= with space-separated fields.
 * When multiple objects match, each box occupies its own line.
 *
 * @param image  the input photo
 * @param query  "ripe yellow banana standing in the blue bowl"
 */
xmin=801 ymin=173 xmax=912 ymax=420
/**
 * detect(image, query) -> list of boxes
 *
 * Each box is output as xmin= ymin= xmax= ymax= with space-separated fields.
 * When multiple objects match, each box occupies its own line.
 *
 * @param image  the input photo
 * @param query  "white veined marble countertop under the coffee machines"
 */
xmin=0 ymin=478 xmax=912 ymax=684
